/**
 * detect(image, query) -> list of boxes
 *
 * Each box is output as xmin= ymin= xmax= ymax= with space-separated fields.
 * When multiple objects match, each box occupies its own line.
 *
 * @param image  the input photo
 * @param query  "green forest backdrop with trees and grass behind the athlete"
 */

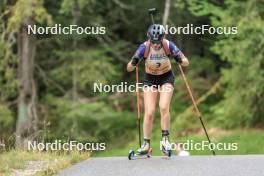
xmin=0 ymin=0 xmax=264 ymax=160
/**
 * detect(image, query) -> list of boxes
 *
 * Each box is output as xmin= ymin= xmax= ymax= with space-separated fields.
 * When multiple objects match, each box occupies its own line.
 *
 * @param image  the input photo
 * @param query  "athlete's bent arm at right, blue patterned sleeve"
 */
xmin=169 ymin=41 xmax=189 ymax=67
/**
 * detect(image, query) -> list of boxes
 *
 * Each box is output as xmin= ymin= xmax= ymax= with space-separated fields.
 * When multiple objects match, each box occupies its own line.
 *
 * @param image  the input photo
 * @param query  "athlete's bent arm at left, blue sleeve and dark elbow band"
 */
xmin=127 ymin=43 xmax=146 ymax=72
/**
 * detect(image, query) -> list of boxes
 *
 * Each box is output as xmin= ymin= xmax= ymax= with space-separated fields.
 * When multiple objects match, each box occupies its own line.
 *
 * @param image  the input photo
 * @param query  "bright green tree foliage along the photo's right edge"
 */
xmin=213 ymin=1 xmax=264 ymax=127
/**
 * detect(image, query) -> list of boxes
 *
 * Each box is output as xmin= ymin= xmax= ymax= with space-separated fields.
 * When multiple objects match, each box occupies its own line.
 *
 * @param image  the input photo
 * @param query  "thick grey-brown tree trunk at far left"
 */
xmin=16 ymin=18 xmax=38 ymax=148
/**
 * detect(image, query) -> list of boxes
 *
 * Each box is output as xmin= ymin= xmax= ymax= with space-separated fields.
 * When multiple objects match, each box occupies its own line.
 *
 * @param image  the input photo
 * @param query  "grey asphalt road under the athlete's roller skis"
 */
xmin=59 ymin=155 xmax=264 ymax=176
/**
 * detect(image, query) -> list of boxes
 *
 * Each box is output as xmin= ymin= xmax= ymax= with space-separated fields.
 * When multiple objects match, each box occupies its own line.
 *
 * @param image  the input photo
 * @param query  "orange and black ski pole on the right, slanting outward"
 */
xmin=178 ymin=64 xmax=215 ymax=155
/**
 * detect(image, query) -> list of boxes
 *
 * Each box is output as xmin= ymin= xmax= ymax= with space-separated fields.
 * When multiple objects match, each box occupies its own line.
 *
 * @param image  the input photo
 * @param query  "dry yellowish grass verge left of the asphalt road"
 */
xmin=0 ymin=150 xmax=90 ymax=176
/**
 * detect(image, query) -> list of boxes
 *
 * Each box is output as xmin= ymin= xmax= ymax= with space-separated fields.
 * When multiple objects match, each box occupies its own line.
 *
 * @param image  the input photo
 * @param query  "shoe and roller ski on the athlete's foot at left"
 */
xmin=128 ymin=142 xmax=152 ymax=160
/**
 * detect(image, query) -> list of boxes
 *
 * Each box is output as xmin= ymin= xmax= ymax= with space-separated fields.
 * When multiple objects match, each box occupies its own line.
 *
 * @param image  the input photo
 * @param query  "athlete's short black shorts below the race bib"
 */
xmin=144 ymin=70 xmax=175 ymax=87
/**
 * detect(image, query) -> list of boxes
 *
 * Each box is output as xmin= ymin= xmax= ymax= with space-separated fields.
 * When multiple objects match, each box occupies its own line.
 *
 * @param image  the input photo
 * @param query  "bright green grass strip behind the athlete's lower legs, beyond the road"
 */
xmin=95 ymin=129 xmax=264 ymax=156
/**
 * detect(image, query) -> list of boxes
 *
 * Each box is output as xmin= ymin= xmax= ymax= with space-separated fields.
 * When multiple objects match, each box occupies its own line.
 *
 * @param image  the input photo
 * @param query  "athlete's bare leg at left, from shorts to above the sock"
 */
xmin=143 ymin=87 xmax=158 ymax=139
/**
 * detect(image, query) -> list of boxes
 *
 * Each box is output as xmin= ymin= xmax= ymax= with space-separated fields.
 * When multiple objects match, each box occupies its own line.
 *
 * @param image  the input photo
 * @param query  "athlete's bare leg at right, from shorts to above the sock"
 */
xmin=159 ymin=83 xmax=173 ymax=131
